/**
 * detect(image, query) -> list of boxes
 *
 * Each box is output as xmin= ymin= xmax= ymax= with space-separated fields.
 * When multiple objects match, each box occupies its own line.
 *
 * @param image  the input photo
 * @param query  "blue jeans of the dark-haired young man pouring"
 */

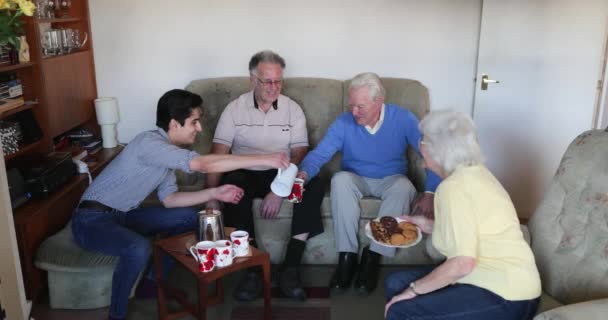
xmin=72 ymin=207 xmax=198 ymax=318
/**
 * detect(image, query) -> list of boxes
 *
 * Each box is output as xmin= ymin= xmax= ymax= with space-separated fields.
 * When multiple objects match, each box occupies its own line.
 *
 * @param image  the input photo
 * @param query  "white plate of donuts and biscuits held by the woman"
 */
xmin=365 ymin=216 xmax=422 ymax=248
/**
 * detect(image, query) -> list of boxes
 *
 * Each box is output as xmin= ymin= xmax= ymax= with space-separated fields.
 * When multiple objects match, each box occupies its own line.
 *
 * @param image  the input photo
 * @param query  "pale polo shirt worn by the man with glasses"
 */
xmin=213 ymin=91 xmax=308 ymax=170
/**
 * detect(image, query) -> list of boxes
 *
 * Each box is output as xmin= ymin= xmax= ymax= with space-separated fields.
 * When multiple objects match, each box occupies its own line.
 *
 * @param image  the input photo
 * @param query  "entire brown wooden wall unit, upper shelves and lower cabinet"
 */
xmin=0 ymin=0 xmax=100 ymax=299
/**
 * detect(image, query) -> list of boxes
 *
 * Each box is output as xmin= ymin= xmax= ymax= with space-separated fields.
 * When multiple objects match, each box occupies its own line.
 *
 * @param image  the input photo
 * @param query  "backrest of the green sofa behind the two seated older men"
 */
xmin=186 ymin=77 xmax=429 ymax=190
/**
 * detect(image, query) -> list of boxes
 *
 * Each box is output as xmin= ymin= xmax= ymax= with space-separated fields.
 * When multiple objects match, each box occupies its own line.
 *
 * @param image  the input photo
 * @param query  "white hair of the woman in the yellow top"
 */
xmin=419 ymin=110 xmax=484 ymax=175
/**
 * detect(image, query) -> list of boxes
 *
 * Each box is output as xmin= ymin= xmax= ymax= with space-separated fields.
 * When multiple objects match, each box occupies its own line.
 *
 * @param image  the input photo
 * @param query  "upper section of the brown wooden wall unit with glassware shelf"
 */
xmin=0 ymin=0 xmax=99 ymax=161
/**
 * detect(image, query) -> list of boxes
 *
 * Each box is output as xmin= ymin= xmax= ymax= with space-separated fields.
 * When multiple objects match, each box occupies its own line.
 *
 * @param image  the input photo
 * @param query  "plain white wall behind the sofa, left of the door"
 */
xmin=90 ymin=0 xmax=481 ymax=142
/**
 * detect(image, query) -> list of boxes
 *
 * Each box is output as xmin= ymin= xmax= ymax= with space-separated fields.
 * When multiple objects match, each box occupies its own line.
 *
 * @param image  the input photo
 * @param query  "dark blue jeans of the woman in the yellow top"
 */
xmin=384 ymin=266 xmax=539 ymax=320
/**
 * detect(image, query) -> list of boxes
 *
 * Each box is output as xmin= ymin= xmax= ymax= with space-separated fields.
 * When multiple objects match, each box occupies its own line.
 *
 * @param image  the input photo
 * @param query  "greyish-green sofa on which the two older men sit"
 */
xmin=178 ymin=77 xmax=440 ymax=265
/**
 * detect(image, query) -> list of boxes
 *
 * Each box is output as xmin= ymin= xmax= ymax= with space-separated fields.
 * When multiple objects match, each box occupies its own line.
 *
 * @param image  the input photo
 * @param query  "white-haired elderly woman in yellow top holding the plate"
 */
xmin=385 ymin=111 xmax=541 ymax=320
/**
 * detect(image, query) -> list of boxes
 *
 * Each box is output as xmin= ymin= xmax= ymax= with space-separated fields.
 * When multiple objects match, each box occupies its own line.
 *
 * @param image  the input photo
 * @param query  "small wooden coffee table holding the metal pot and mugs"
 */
xmin=154 ymin=232 xmax=271 ymax=320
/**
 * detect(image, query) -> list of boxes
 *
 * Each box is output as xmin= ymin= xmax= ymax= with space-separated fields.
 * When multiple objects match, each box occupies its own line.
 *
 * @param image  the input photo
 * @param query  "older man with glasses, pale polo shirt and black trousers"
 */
xmin=207 ymin=51 xmax=323 ymax=301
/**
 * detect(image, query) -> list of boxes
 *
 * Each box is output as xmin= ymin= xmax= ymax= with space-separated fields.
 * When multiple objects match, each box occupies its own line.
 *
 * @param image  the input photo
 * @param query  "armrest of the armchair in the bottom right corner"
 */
xmin=534 ymin=299 xmax=608 ymax=320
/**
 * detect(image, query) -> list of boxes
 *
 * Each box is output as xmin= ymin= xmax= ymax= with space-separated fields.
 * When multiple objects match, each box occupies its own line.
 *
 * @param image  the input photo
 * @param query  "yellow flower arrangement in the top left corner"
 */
xmin=0 ymin=0 xmax=36 ymax=50
